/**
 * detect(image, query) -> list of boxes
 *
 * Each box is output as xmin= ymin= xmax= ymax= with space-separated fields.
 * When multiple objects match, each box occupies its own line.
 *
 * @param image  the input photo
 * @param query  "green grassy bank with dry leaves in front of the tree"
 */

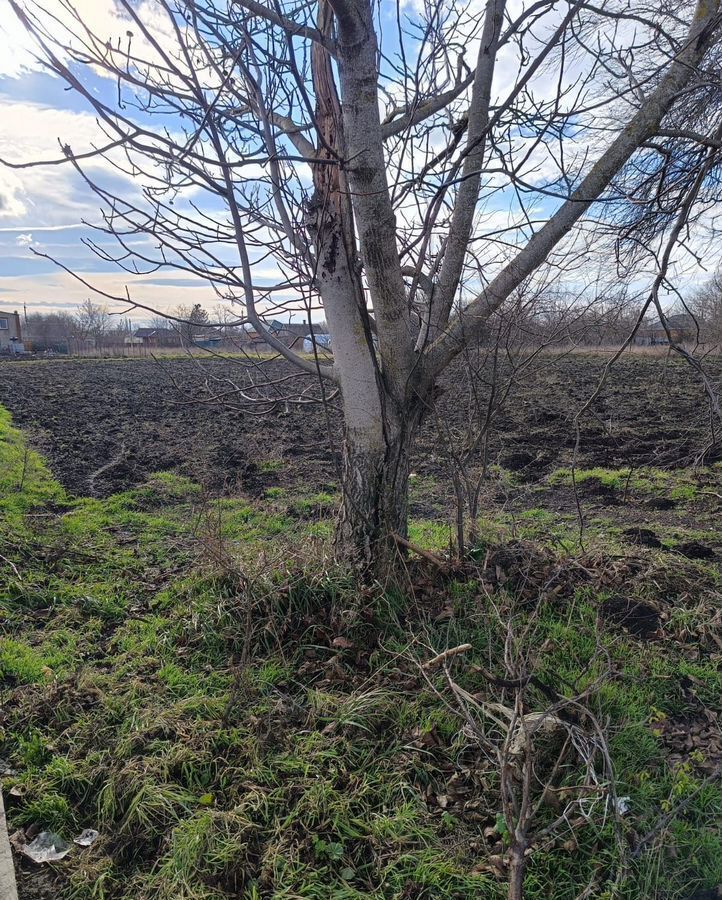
xmin=0 ymin=413 xmax=722 ymax=900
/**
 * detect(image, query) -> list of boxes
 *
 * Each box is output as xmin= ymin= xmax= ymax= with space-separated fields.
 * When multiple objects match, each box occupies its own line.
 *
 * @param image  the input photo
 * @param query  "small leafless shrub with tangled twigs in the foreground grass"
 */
xmin=421 ymin=596 xmax=625 ymax=900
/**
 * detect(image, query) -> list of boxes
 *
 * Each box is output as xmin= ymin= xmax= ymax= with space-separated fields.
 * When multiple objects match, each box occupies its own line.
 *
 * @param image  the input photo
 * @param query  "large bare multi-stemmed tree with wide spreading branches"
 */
xmin=5 ymin=0 xmax=722 ymax=572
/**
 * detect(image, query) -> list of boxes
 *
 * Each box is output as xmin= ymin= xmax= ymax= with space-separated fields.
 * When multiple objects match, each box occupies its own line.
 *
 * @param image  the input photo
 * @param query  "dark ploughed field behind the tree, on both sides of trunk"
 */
xmin=0 ymin=354 xmax=722 ymax=536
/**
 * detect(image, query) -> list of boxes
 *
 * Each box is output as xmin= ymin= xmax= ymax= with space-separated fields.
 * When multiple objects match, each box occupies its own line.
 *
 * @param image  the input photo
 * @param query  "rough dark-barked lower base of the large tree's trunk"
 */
xmin=336 ymin=414 xmax=416 ymax=581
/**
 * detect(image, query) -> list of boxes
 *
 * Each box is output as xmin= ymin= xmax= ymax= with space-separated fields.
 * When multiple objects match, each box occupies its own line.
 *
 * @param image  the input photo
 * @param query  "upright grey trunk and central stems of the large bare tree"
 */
xmin=310 ymin=0 xmax=417 ymax=580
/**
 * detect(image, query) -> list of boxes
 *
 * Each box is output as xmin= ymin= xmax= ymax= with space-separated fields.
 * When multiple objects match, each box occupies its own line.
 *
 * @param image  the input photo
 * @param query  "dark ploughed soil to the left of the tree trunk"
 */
xmin=0 ymin=359 xmax=334 ymax=496
